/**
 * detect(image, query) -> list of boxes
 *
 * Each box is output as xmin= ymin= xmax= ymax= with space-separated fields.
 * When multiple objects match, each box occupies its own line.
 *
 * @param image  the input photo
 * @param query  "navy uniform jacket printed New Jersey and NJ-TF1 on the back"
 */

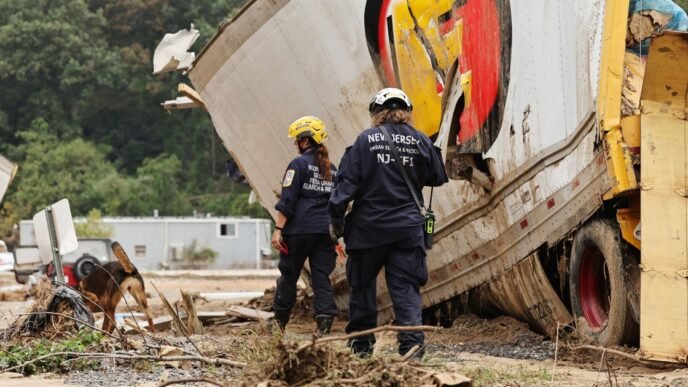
xmin=329 ymin=124 xmax=448 ymax=250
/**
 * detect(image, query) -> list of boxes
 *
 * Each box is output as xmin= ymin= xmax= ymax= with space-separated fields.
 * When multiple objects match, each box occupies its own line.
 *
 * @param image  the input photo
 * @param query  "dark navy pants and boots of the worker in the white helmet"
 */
xmin=346 ymin=244 xmax=428 ymax=355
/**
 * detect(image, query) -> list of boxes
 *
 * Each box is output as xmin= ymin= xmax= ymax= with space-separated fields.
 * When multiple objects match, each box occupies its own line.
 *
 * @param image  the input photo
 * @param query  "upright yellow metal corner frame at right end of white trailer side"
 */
xmin=597 ymin=0 xmax=638 ymax=196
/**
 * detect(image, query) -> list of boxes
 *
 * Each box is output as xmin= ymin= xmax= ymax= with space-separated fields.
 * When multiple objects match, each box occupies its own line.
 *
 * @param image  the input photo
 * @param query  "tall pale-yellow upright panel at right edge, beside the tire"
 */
xmin=640 ymin=32 xmax=688 ymax=362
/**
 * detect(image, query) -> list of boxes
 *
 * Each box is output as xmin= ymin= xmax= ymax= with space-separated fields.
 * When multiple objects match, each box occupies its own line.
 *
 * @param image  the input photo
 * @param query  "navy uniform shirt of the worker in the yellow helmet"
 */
xmin=275 ymin=148 xmax=337 ymax=235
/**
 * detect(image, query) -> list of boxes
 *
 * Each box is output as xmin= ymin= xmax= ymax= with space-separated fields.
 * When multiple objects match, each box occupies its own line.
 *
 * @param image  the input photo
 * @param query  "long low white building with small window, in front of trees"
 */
xmin=19 ymin=216 xmax=272 ymax=270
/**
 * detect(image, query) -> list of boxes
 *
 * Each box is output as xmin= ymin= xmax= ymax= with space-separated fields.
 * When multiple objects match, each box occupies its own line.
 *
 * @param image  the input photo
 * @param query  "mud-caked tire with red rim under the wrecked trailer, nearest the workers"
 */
xmin=569 ymin=219 xmax=638 ymax=346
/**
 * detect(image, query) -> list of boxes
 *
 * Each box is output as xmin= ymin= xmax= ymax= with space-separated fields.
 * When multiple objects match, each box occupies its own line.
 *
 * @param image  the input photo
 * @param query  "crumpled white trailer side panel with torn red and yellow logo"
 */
xmin=189 ymin=0 xmax=609 ymax=325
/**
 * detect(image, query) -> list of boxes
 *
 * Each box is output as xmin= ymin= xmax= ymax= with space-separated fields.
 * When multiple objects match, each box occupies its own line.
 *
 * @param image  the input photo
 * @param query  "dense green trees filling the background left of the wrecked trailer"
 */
xmin=0 ymin=0 xmax=265 ymax=241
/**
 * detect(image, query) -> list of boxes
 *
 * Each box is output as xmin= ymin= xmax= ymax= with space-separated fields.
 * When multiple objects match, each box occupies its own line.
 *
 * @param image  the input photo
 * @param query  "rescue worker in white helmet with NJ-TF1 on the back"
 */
xmin=329 ymin=88 xmax=448 ymax=358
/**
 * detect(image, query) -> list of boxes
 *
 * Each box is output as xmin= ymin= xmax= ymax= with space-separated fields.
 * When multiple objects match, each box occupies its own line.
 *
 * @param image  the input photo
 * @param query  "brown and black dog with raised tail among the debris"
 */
xmin=79 ymin=242 xmax=155 ymax=333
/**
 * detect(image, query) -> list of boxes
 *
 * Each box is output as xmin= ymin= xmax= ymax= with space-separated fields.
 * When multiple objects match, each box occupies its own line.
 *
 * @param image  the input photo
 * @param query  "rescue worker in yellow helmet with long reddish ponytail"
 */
xmin=272 ymin=116 xmax=337 ymax=335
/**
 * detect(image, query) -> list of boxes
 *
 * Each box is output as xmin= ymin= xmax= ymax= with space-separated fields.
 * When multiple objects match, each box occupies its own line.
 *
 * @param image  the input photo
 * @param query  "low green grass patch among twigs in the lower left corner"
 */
xmin=0 ymin=328 xmax=103 ymax=375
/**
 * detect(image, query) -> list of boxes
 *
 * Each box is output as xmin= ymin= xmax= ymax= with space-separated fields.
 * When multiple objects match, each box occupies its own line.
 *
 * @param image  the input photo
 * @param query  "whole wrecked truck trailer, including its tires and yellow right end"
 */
xmin=188 ymin=0 xmax=688 ymax=361
